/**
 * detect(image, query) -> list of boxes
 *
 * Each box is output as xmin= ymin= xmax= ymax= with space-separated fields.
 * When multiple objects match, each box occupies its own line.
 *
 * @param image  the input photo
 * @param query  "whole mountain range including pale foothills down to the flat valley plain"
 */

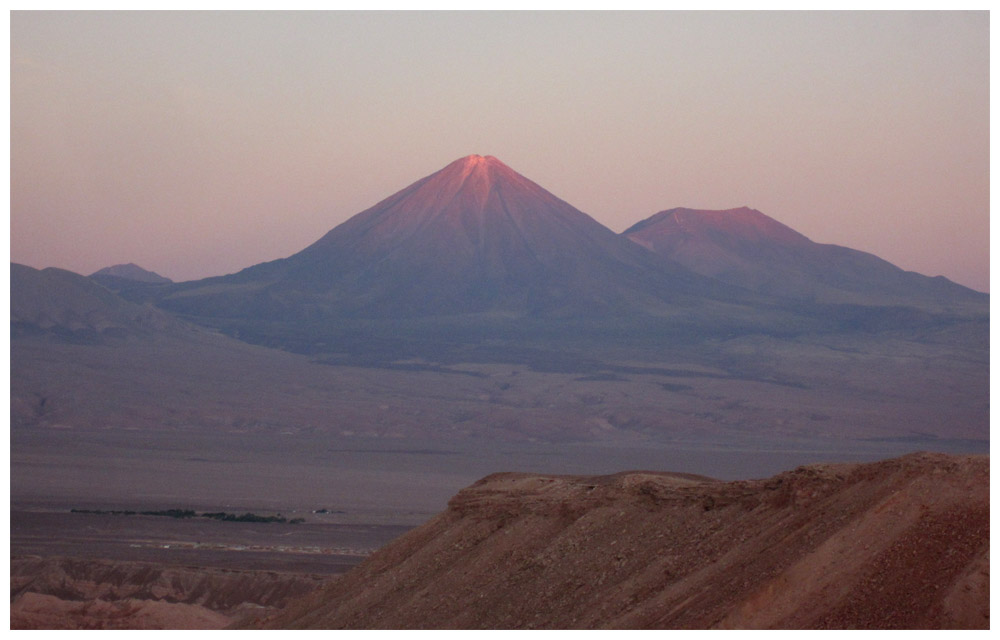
xmin=11 ymin=156 xmax=989 ymax=447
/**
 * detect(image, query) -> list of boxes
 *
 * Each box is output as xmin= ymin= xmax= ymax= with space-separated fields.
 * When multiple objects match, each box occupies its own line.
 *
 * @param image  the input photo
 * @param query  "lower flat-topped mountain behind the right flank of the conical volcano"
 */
xmin=623 ymin=207 xmax=988 ymax=311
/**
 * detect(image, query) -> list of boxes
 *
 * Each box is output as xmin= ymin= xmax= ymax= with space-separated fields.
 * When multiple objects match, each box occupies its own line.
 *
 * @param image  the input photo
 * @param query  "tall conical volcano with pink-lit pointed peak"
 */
xmin=160 ymin=155 xmax=733 ymax=320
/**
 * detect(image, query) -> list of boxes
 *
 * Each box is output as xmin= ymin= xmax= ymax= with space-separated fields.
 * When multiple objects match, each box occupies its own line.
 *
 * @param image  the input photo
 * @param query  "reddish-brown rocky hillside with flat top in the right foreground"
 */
xmin=253 ymin=454 xmax=990 ymax=629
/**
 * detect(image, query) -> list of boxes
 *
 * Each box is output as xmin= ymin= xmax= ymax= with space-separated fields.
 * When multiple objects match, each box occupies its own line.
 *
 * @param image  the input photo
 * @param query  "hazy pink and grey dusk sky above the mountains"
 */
xmin=10 ymin=11 xmax=989 ymax=291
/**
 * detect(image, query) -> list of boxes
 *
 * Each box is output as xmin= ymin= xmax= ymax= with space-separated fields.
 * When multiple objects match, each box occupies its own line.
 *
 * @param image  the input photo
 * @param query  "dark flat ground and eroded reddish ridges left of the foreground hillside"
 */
xmin=11 ymin=506 xmax=410 ymax=629
